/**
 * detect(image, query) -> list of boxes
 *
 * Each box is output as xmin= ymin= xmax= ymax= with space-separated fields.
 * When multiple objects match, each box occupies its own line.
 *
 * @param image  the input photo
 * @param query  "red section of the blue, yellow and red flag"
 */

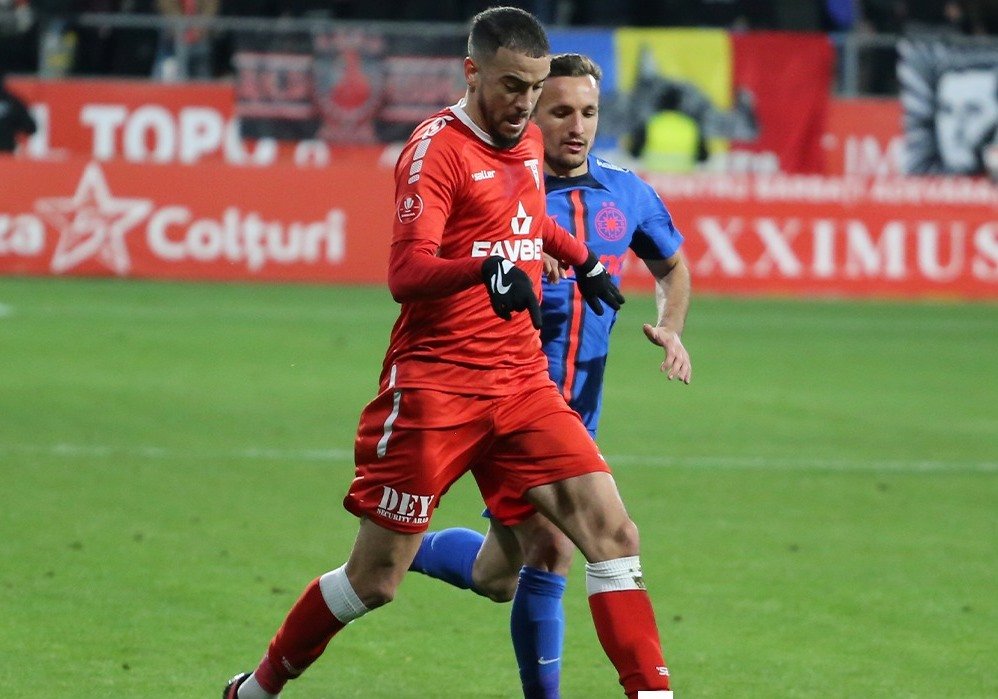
xmin=731 ymin=32 xmax=834 ymax=173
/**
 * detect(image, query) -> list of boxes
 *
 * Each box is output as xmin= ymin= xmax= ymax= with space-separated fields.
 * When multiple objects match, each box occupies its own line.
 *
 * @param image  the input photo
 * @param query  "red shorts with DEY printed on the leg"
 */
xmin=343 ymin=384 xmax=610 ymax=532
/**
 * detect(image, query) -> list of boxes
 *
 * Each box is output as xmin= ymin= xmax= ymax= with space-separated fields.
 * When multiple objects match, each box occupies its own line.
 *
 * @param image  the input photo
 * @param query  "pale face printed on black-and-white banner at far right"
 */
xmin=936 ymin=70 xmax=998 ymax=173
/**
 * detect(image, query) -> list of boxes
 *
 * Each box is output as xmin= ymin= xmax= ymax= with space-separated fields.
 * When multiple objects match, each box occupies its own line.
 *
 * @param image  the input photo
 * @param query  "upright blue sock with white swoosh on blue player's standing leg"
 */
xmin=509 ymin=566 xmax=566 ymax=699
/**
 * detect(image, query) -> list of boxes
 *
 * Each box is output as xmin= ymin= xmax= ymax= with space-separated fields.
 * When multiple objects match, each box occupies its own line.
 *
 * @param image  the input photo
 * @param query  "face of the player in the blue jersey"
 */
xmin=534 ymin=75 xmax=599 ymax=177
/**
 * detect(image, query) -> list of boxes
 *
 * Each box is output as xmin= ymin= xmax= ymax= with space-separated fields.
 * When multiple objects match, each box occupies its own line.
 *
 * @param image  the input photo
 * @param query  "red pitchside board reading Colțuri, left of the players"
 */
xmin=0 ymin=157 xmax=394 ymax=282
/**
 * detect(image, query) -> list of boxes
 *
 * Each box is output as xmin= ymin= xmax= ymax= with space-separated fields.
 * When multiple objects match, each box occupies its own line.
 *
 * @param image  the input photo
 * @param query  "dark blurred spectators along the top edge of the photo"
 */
xmin=0 ymin=0 xmax=998 ymax=79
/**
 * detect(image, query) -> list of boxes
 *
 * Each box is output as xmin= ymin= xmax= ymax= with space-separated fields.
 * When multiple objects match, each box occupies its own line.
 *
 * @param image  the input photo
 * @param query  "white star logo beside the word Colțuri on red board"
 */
xmin=35 ymin=163 xmax=152 ymax=275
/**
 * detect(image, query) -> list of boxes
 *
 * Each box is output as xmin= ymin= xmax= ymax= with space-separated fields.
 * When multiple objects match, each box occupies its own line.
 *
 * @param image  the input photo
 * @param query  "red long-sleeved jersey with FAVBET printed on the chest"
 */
xmin=382 ymin=101 xmax=588 ymax=396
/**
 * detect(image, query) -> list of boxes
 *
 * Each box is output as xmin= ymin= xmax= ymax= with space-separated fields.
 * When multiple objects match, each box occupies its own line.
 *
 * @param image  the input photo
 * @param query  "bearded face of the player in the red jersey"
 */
xmin=465 ymin=48 xmax=551 ymax=148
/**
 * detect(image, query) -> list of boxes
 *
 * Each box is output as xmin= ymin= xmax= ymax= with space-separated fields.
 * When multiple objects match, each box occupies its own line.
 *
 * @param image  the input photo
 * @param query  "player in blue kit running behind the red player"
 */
xmin=411 ymin=54 xmax=692 ymax=699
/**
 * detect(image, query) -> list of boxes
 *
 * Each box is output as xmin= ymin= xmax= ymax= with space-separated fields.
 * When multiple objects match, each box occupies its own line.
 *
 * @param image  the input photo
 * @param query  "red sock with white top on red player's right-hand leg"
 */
xmin=586 ymin=556 xmax=669 ymax=699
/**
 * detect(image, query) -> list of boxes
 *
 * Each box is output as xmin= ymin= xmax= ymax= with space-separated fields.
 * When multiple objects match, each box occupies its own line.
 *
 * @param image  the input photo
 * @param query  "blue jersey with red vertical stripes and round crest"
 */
xmin=541 ymin=155 xmax=683 ymax=437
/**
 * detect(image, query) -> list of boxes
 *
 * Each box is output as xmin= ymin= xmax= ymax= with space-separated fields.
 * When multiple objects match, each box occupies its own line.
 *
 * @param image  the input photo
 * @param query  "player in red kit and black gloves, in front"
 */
xmin=223 ymin=7 xmax=671 ymax=699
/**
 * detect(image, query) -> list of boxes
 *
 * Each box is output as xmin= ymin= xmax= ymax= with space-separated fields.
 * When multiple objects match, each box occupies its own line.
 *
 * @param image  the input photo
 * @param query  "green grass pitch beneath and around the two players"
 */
xmin=0 ymin=278 xmax=998 ymax=699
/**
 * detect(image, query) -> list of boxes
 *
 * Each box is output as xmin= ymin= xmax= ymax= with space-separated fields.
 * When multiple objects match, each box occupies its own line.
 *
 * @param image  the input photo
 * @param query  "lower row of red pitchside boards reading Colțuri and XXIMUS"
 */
xmin=0 ymin=123 xmax=998 ymax=299
